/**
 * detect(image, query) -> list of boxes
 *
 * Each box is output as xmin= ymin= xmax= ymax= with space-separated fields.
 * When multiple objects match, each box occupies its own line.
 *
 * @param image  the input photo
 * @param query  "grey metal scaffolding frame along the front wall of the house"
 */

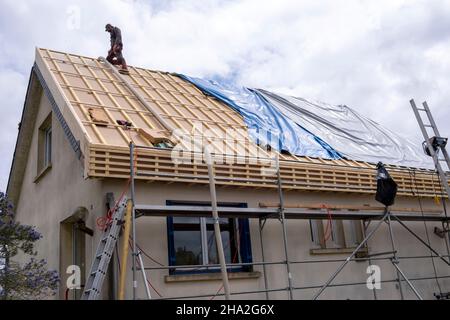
xmin=125 ymin=142 xmax=450 ymax=300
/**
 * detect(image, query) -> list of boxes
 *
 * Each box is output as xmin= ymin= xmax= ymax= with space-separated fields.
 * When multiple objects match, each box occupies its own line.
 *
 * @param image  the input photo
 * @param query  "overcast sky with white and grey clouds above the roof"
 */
xmin=0 ymin=0 xmax=450 ymax=190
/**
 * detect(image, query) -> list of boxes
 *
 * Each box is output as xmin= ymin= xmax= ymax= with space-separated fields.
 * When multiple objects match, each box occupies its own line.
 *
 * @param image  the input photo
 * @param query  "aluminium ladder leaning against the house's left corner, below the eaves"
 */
xmin=81 ymin=199 xmax=127 ymax=300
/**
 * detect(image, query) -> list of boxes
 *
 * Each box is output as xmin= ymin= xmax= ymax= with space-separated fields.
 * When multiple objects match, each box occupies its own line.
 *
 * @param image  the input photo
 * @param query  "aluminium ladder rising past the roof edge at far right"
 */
xmin=410 ymin=100 xmax=450 ymax=201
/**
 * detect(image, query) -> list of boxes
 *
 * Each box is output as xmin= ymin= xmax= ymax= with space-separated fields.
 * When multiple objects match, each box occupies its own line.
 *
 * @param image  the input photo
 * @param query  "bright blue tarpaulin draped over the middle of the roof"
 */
xmin=178 ymin=74 xmax=341 ymax=159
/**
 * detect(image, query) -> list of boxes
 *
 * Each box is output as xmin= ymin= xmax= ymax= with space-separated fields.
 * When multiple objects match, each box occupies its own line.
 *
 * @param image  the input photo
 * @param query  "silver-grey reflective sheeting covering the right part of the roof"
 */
xmin=257 ymin=90 xmax=434 ymax=168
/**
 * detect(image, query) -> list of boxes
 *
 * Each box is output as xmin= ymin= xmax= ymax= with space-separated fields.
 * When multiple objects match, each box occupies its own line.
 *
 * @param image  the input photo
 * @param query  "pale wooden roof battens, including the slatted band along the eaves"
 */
xmin=36 ymin=49 xmax=444 ymax=197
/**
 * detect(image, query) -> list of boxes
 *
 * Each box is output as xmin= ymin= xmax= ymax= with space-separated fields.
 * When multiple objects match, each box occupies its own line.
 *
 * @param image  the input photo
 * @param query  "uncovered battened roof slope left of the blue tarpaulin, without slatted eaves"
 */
xmin=38 ymin=49 xmax=262 ymax=156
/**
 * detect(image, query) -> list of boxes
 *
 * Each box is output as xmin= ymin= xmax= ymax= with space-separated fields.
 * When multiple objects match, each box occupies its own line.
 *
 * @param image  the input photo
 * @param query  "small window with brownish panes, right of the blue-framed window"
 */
xmin=309 ymin=220 xmax=363 ymax=249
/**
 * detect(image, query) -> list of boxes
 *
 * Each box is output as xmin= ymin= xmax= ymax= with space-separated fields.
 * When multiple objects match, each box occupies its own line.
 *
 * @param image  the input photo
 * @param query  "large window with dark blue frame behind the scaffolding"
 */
xmin=167 ymin=201 xmax=252 ymax=274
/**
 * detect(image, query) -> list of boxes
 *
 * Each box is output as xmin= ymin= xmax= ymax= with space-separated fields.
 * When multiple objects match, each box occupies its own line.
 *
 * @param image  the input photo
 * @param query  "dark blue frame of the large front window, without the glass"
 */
xmin=166 ymin=200 xmax=253 ymax=275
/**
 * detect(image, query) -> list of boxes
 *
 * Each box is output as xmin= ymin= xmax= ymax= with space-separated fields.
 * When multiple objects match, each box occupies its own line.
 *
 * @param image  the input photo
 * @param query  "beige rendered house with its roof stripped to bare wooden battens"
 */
xmin=7 ymin=49 xmax=450 ymax=299
